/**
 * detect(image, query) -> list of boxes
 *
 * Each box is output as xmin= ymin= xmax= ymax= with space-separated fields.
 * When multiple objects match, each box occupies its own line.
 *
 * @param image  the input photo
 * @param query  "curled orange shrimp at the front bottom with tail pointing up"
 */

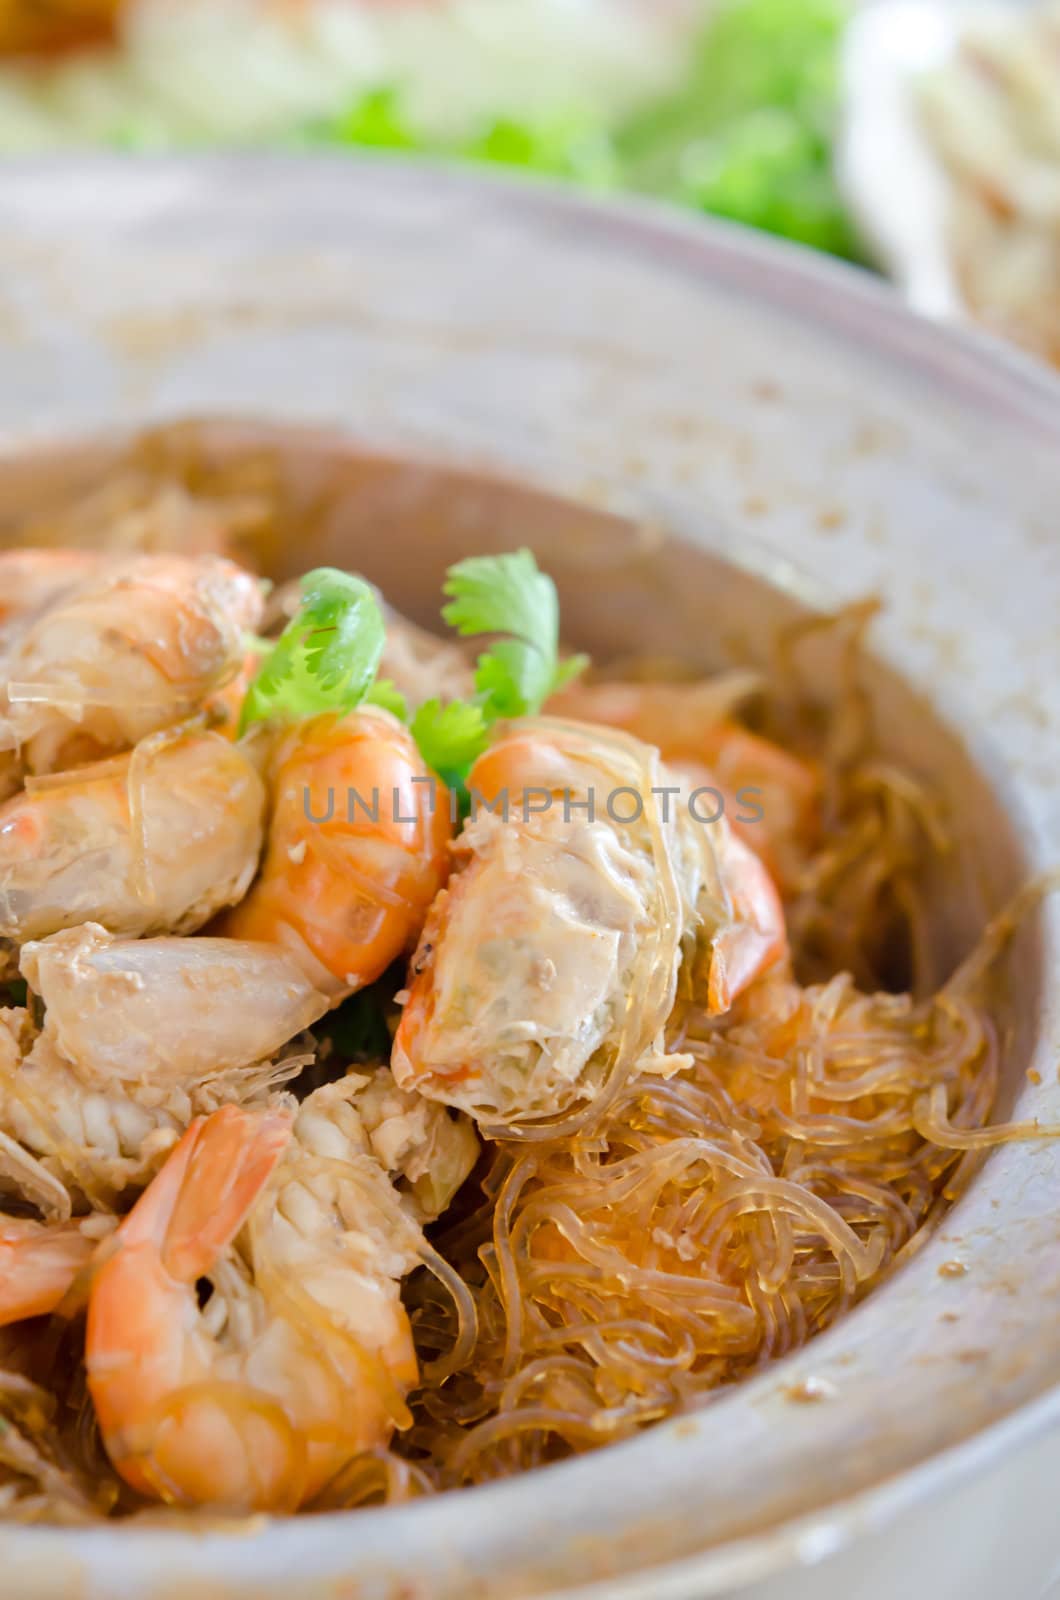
xmin=85 ymin=1107 xmax=421 ymax=1512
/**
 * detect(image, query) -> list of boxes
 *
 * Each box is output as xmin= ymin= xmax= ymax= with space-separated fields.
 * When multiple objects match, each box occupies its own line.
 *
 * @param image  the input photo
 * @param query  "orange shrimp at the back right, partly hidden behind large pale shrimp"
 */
xmin=552 ymin=678 xmax=821 ymax=890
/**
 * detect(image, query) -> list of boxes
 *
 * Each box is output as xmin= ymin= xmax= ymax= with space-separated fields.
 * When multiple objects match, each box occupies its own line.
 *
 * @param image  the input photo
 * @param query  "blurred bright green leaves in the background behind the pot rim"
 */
xmin=312 ymin=0 xmax=857 ymax=258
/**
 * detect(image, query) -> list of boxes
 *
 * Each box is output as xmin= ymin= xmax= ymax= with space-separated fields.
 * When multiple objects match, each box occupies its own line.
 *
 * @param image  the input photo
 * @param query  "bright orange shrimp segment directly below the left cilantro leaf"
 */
xmin=223 ymin=709 xmax=452 ymax=1000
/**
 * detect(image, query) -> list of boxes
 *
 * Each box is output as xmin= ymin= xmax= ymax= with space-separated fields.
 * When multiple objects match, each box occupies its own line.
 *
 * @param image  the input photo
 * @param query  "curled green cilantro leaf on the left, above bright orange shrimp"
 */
xmin=240 ymin=566 xmax=386 ymax=733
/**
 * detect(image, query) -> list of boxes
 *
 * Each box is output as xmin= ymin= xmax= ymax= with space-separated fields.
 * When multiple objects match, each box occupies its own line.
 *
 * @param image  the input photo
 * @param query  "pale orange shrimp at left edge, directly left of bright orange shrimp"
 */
xmin=0 ymin=733 xmax=266 ymax=944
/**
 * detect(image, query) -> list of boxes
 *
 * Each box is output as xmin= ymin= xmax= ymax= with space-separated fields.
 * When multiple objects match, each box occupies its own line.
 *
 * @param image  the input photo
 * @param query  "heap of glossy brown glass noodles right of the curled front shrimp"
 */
xmin=397 ymin=934 xmax=1039 ymax=1486
